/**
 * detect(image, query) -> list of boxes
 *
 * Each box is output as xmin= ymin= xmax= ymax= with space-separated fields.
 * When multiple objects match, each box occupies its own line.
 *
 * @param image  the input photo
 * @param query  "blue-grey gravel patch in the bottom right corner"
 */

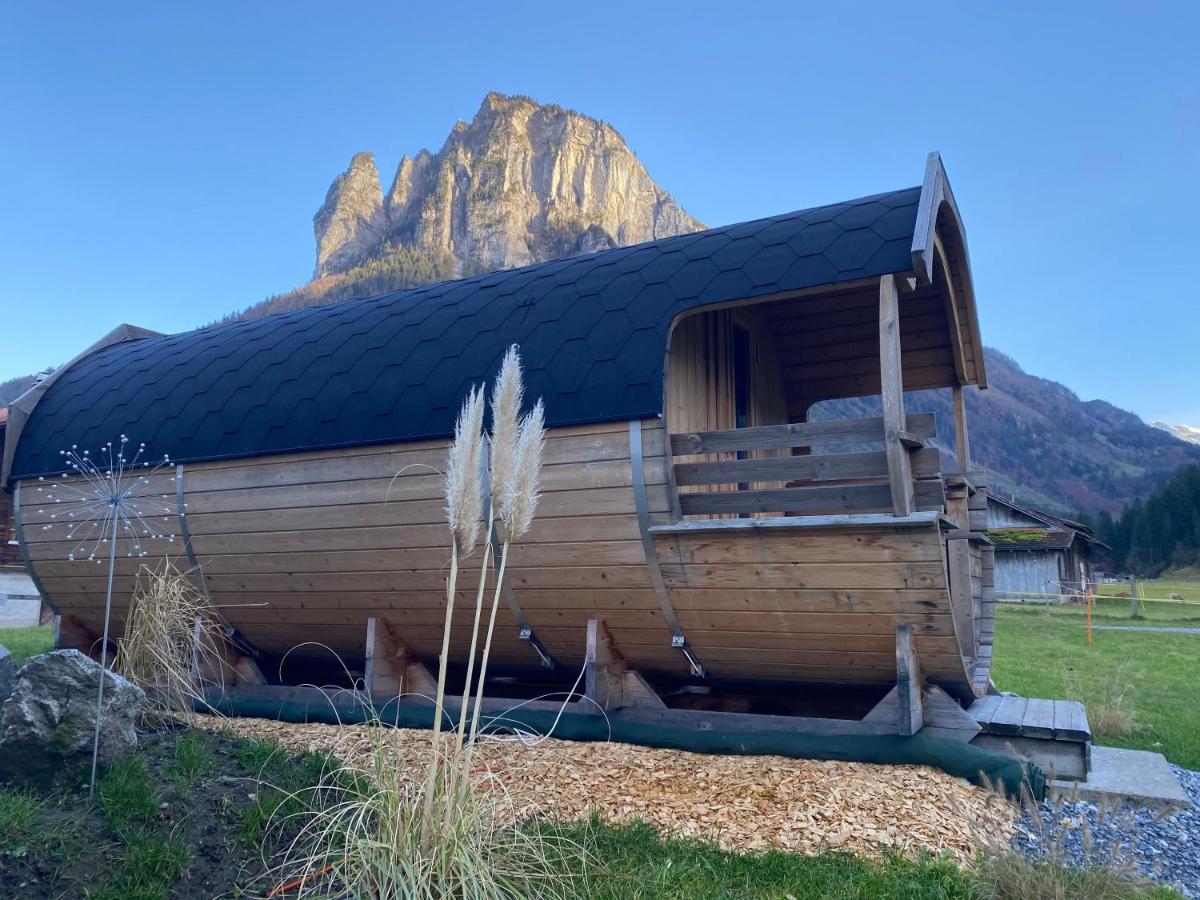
xmin=1014 ymin=766 xmax=1200 ymax=899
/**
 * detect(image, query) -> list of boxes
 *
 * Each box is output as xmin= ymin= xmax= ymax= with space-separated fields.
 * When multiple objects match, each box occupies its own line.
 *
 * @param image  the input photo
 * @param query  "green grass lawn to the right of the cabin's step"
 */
xmin=992 ymin=607 xmax=1200 ymax=769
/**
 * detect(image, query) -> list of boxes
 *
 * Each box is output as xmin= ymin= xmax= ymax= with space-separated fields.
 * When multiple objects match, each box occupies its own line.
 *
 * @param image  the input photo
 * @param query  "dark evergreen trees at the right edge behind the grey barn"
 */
xmin=1093 ymin=464 xmax=1200 ymax=577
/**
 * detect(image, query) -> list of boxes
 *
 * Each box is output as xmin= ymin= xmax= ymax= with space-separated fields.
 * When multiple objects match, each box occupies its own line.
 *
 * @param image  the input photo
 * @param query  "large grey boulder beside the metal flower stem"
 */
xmin=0 ymin=650 xmax=145 ymax=786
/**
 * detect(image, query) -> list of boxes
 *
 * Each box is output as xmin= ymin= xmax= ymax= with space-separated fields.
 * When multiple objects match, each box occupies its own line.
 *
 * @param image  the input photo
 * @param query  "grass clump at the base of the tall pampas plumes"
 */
xmin=262 ymin=720 xmax=584 ymax=900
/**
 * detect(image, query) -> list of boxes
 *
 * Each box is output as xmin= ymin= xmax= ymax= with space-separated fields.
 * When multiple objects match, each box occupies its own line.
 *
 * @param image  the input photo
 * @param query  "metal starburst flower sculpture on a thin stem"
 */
xmin=37 ymin=434 xmax=175 ymax=796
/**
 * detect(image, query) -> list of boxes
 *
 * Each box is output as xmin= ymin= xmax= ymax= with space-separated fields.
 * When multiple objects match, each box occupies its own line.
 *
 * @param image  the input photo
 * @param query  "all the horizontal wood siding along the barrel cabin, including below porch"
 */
xmin=23 ymin=420 xmax=984 ymax=686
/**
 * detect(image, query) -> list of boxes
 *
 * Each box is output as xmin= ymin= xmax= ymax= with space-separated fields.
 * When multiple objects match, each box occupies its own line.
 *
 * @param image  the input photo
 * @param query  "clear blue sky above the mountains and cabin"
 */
xmin=0 ymin=0 xmax=1200 ymax=424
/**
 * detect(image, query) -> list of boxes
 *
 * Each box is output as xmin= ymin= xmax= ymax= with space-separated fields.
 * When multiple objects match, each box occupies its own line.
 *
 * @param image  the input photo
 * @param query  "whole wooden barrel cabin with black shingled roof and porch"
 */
xmin=4 ymin=154 xmax=992 ymax=720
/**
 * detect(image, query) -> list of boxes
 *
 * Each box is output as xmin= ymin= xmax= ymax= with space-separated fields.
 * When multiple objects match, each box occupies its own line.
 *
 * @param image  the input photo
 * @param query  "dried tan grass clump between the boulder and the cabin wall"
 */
xmin=114 ymin=560 xmax=223 ymax=716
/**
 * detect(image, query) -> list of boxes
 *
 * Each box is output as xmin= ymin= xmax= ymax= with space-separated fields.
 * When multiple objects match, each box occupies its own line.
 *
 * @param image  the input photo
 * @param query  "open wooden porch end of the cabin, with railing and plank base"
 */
xmin=648 ymin=266 xmax=994 ymax=703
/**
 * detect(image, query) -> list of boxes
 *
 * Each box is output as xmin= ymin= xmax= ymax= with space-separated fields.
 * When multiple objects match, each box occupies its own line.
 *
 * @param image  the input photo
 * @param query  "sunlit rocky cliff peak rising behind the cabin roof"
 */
xmin=313 ymin=94 xmax=703 ymax=278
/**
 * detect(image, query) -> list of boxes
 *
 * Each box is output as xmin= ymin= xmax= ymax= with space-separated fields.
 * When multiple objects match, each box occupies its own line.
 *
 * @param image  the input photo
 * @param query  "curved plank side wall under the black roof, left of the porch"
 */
xmin=14 ymin=420 xmax=696 ymax=671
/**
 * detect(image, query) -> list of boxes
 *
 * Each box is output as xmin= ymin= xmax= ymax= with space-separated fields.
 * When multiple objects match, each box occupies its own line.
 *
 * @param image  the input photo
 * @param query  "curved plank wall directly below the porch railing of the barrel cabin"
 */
xmin=655 ymin=524 xmax=970 ymax=696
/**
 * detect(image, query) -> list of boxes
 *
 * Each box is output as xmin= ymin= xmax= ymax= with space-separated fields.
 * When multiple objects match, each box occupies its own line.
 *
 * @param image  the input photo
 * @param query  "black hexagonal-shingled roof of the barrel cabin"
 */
xmin=12 ymin=187 xmax=920 ymax=478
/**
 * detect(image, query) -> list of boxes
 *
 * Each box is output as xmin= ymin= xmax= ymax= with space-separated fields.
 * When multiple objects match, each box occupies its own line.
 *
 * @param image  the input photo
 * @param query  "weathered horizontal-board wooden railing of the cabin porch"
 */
xmin=671 ymin=413 xmax=946 ymax=516
